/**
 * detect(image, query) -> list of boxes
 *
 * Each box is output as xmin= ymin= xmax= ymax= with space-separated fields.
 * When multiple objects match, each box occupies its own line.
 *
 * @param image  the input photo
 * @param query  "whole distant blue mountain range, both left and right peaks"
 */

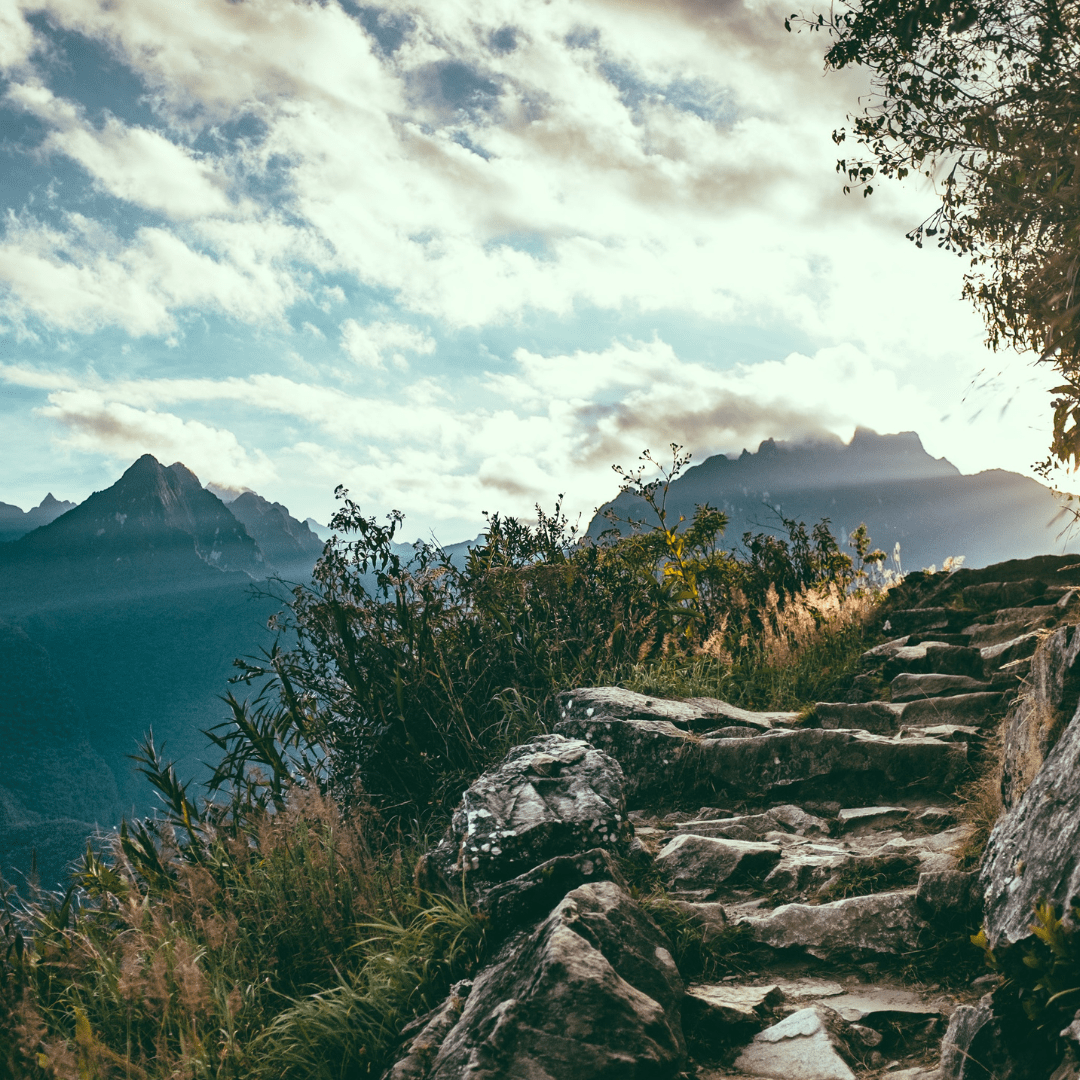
xmin=0 ymin=431 xmax=1078 ymax=885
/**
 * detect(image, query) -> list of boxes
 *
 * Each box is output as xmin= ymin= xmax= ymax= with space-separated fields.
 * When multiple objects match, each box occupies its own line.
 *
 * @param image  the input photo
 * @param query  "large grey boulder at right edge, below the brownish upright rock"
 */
xmin=980 ymin=691 xmax=1080 ymax=945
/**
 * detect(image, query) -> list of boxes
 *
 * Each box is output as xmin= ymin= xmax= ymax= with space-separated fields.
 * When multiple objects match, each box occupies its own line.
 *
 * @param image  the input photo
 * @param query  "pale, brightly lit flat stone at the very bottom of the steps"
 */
xmin=734 ymin=1007 xmax=855 ymax=1080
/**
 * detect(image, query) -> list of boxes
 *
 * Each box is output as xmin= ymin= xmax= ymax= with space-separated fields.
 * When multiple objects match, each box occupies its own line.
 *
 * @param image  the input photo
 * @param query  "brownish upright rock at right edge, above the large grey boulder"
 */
xmin=1001 ymin=626 xmax=1080 ymax=807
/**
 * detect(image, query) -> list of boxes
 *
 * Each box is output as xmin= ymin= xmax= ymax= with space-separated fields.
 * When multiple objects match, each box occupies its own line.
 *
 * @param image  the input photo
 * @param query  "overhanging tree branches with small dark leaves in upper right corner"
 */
xmin=785 ymin=0 xmax=1080 ymax=467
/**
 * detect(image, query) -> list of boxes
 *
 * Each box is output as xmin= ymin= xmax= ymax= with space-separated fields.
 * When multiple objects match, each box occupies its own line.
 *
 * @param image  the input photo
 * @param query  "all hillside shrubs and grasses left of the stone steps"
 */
xmin=0 ymin=457 xmax=883 ymax=1080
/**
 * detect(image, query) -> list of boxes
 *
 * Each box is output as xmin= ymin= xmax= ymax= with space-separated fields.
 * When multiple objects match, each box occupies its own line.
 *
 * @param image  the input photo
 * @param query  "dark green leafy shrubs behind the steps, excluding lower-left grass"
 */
xmin=230 ymin=447 xmax=879 ymax=815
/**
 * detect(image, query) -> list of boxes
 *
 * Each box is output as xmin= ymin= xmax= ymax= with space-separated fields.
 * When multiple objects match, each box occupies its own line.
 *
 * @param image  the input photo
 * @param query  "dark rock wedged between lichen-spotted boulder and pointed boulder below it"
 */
xmin=476 ymin=839 xmax=630 ymax=937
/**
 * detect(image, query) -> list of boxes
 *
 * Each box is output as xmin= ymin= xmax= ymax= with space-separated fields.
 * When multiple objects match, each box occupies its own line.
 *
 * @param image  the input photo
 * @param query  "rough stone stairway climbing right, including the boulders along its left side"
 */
xmin=387 ymin=559 xmax=1080 ymax=1080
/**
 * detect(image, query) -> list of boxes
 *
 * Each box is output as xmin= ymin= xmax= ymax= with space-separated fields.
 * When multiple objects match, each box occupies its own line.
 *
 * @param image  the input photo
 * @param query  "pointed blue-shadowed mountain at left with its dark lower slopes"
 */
xmin=0 ymin=455 xmax=282 ymax=885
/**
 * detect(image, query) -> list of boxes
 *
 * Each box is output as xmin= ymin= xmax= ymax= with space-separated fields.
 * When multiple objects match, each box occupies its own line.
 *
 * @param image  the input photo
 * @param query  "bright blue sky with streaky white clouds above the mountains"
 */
xmin=0 ymin=0 xmax=1053 ymax=542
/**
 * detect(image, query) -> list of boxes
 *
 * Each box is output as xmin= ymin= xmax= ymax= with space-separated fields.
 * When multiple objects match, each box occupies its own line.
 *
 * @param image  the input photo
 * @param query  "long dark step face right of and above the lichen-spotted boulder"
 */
xmin=555 ymin=716 xmax=967 ymax=809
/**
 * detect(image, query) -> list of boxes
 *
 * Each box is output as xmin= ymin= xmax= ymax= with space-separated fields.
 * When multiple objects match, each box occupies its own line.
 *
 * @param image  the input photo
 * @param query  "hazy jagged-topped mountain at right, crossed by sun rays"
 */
xmin=589 ymin=428 xmax=1080 ymax=570
